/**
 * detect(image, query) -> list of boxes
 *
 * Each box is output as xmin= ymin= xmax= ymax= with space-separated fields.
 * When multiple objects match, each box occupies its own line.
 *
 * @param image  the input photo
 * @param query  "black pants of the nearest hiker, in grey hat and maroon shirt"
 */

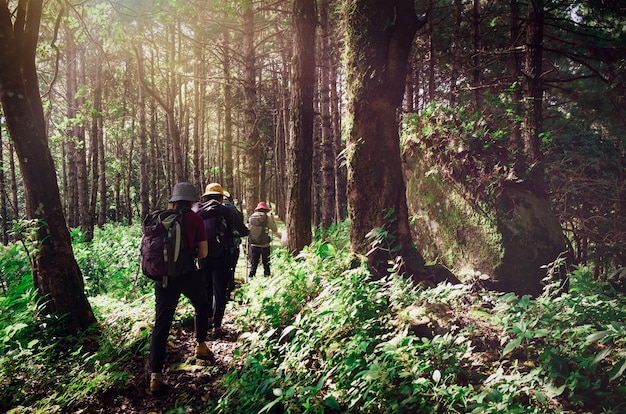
xmin=150 ymin=271 xmax=209 ymax=372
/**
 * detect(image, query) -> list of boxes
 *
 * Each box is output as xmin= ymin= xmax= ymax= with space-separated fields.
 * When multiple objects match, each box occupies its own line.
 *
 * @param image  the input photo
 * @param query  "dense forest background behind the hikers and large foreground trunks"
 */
xmin=0 ymin=0 xmax=626 ymax=300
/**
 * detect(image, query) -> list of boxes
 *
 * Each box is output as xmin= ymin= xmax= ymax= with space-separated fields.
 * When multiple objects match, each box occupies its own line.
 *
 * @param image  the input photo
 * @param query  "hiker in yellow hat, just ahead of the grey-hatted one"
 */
xmin=198 ymin=183 xmax=248 ymax=338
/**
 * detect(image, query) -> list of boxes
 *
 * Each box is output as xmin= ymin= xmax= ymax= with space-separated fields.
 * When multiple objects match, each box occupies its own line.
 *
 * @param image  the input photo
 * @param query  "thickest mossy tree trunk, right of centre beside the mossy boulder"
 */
xmin=346 ymin=0 xmax=424 ymax=277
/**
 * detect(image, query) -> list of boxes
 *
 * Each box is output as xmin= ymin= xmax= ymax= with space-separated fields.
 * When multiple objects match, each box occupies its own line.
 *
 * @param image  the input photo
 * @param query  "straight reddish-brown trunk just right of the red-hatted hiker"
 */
xmin=287 ymin=0 xmax=317 ymax=252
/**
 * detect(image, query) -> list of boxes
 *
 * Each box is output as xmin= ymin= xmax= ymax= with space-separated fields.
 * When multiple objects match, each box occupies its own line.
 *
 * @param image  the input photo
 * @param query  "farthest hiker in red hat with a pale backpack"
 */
xmin=248 ymin=201 xmax=278 ymax=279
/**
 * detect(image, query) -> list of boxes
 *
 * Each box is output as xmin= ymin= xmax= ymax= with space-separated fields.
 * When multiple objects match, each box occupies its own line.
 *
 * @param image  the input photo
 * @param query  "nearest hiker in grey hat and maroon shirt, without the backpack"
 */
xmin=150 ymin=182 xmax=213 ymax=394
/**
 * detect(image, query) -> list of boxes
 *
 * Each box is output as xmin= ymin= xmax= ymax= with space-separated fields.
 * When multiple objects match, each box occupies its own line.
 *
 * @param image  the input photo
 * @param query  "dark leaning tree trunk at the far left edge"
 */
xmin=0 ymin=0 xmax=96 ymax=332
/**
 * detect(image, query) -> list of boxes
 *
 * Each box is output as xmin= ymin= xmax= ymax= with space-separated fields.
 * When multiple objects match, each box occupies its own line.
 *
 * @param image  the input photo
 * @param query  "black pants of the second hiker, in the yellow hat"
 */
xmin=199 ymin=252 xmax=230 ymax=328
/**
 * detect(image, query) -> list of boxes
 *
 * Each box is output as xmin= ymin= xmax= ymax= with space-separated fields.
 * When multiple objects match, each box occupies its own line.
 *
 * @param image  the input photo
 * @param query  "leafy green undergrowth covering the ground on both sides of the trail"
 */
xmin=0 ymin=220 xmax=626 ymax=413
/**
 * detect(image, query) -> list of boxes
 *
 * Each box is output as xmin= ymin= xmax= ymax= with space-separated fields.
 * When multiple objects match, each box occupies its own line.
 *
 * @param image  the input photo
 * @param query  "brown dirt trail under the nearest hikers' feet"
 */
xmin=90 ymin=313 xmax=239 ymax=414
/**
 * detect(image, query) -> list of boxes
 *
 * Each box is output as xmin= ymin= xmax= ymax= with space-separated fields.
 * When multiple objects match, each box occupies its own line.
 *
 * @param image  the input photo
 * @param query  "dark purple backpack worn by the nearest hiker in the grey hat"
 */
xmin=140 ymin=209 xmax=194 ymax=281
